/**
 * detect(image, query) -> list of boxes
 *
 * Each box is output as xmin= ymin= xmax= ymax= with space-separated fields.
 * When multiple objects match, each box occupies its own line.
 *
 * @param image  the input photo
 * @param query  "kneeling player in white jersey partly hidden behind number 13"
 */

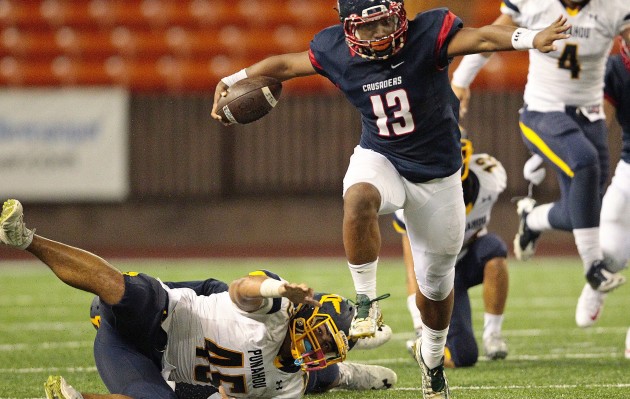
xmin=394 ymin=139 xmax=509 ymax=367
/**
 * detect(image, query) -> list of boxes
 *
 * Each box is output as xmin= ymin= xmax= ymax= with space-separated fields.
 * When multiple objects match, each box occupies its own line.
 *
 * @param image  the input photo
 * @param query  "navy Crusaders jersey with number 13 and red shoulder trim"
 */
xmin=310 ymin=8 xmax=463 ymax=183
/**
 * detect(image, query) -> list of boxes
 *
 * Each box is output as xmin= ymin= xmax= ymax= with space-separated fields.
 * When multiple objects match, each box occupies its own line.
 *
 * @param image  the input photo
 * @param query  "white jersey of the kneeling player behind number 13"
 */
xmin=394 ymin=154 xmax=507 ymax=247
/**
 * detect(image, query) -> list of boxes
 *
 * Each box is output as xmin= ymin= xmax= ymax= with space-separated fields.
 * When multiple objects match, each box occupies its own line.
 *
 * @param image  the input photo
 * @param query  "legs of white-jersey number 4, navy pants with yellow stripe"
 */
xmin=514 ymin=108 xmax=625 ymax=312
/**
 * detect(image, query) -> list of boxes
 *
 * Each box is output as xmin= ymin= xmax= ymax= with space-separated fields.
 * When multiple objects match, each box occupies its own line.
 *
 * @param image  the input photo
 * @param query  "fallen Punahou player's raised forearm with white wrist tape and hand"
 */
xmin=229 ymin=275 xmax=319 ymax=312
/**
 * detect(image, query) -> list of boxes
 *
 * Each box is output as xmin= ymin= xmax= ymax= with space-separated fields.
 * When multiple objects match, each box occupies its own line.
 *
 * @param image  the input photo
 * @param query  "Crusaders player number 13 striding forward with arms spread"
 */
xmin=212 ymin=0 xmax=569 ymax=398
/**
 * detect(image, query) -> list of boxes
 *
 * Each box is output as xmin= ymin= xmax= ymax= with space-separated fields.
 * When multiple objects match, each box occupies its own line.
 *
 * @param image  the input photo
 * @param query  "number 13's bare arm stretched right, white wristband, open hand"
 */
xmin=448 ymin=16 xmax=571 ymax=57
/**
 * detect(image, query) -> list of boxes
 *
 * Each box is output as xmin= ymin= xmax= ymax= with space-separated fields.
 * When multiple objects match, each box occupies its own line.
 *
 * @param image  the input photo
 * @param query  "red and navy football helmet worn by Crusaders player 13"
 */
xmin=337 ymin=0 xmax=408 ymax=60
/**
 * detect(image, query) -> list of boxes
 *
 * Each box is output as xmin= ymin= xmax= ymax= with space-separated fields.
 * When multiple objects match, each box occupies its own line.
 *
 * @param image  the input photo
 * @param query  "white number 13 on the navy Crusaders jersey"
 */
xmin=370 ymin=89 xmax=415 ymax=137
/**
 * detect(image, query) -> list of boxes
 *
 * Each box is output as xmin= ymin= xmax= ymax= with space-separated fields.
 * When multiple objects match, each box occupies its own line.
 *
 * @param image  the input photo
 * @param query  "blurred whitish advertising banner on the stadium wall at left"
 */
xmin=0 ymin=88 xmax=129 ymax=202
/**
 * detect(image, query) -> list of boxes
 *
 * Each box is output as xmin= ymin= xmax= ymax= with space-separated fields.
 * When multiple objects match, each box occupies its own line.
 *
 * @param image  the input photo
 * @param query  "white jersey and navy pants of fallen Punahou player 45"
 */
xmin=94 ymin=271 xmax=308 ymax=399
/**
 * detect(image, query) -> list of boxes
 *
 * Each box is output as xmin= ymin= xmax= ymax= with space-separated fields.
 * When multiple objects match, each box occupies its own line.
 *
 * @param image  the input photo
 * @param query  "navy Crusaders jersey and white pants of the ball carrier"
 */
xmin=309 ymin=8 xmax=465 ymax=301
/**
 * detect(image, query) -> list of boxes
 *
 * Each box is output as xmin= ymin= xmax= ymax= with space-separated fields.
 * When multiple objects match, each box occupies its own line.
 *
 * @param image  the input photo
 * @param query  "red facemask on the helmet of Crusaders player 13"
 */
xmin=342 ymin=1 xmax=408 ymax=60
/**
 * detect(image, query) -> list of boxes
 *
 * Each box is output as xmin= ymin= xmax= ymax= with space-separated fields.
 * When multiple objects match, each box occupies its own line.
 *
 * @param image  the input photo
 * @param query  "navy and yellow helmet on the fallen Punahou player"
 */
xmin=289 ymin=293 xmax=356 ymax=371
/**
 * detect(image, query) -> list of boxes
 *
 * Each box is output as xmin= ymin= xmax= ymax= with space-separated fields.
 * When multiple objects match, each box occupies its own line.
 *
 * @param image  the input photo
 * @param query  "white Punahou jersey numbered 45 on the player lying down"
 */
xmin=162 ymin=274 xmax=307 ymax=398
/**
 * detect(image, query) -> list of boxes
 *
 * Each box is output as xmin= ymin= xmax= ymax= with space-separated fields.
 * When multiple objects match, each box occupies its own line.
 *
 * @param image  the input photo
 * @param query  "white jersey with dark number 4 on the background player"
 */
xmin=501 ymin=0 xmax=630 ymax=114
